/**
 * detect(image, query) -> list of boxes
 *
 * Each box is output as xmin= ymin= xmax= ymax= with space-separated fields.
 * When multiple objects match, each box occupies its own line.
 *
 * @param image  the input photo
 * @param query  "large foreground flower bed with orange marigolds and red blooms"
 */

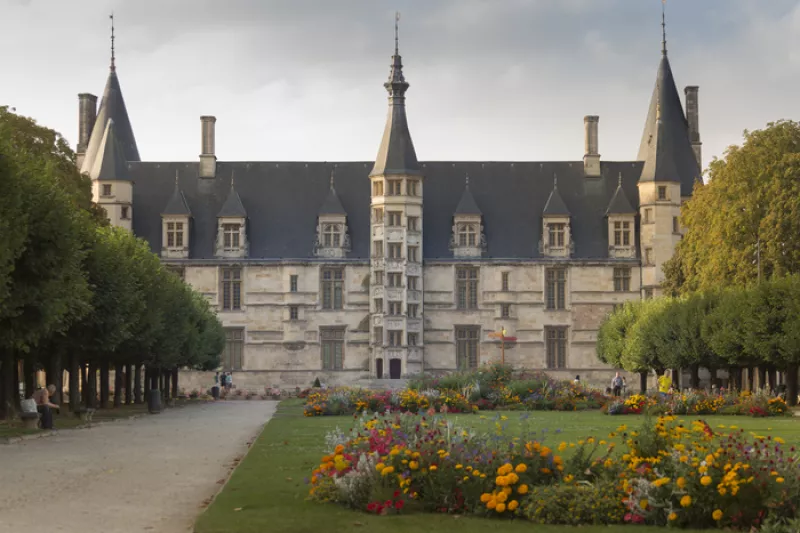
xmin=309 ymin=411 xmax=800 ymax=531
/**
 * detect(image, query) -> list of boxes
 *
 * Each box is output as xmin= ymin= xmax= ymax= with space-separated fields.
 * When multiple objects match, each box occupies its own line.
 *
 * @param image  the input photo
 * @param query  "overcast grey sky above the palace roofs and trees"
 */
xmin=0 ymin=0 xmax=800 ymax=170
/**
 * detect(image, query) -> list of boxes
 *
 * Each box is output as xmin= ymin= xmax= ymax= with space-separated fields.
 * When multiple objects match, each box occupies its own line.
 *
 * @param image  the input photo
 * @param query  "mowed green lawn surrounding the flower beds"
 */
xmin=195 ymin=400 xmax=800 ymax=533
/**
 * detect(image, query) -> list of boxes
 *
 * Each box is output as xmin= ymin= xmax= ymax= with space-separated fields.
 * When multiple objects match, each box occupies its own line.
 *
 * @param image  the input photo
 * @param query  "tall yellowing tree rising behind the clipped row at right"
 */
xmin=664 ymin=121 xmax=800 ymax=294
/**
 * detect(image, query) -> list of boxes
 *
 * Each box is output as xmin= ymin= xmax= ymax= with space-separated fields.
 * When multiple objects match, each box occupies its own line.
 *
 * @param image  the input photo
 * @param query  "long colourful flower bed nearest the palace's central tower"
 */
xmin=303 ymin=364 xmax=608 ymax=416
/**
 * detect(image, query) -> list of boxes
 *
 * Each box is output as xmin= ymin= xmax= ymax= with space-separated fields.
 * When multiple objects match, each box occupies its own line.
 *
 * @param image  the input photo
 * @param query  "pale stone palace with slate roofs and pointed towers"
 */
xmin=77 ymin=18 xmax=701 ymax=388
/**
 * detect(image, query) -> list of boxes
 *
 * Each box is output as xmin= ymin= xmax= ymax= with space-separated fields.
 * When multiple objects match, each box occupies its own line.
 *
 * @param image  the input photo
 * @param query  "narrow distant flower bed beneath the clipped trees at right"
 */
xmin=605 ymin=391 xmax=791 ymax=417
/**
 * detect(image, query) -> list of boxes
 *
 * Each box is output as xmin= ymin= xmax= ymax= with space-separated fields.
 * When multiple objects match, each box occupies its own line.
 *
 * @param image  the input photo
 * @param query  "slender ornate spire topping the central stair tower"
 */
xmin=370 ymin=13 xmax=421 ymax=176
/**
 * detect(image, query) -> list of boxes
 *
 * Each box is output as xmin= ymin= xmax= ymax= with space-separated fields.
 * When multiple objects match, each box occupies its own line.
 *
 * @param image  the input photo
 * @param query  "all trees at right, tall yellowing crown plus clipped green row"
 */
xmin=597 ymin=121 xmax=800 ymax=404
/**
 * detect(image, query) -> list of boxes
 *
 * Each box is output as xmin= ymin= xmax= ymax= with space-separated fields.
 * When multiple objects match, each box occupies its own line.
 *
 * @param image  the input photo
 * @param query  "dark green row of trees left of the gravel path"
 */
xmin=0 ymin=107 xmax=224 ymax=418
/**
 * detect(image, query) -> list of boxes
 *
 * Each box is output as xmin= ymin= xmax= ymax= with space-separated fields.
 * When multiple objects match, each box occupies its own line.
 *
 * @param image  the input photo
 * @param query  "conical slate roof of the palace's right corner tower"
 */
xmin=637 ymin=51 xmax=701 ymax=196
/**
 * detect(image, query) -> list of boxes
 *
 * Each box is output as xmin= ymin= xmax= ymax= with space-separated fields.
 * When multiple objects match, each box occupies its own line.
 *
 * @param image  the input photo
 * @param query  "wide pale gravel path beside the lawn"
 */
xmin=0 ymin=401 xmax=277 ymax=533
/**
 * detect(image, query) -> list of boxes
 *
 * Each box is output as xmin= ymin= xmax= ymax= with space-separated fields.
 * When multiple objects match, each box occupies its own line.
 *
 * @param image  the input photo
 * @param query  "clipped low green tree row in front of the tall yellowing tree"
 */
xmin=597 ymin=275 xmax=800 ymax=405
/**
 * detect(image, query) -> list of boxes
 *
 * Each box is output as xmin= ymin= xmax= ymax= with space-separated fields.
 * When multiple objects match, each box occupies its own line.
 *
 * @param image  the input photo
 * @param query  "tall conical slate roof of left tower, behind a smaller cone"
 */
xmin=81 ymin=68 xmax=141 ymax=173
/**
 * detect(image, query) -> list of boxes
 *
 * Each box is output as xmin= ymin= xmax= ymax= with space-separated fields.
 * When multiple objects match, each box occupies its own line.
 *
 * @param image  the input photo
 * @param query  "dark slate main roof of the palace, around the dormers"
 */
xmin=128 ymin=161 xmax=642 ymax=261
